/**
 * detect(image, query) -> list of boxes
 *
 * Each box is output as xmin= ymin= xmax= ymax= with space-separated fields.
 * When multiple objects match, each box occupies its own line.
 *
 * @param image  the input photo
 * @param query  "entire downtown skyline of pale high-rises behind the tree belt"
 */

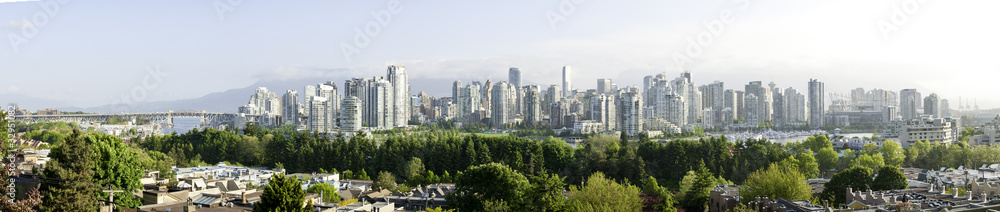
xmin=234 ymin=65 xmax=957 ymax=142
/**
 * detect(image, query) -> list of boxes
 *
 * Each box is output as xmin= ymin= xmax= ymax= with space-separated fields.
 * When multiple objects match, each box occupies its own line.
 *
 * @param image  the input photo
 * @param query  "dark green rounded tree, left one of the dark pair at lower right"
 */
xmin=823 ymin=166 xmax=872 ymax=205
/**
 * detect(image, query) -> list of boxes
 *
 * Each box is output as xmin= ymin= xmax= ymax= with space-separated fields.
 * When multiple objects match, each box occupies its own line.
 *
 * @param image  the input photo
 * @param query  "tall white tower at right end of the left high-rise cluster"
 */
xmin=388 ymin=65 xmax=410 ymax=127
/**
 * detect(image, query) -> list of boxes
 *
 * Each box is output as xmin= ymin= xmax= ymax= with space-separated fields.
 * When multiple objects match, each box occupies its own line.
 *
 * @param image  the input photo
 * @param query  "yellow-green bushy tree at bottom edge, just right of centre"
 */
xmin=568 ymin=172 xmax=642 ymax=211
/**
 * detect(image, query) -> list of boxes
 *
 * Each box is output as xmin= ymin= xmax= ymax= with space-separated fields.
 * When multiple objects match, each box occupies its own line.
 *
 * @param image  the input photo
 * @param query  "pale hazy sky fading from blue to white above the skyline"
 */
xmin=0 ymin=0 xmax=1000 ymax=108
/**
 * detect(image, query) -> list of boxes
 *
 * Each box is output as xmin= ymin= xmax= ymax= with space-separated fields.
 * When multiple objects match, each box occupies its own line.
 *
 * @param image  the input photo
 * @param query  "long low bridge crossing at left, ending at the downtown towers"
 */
xmin=14 ymin=110 xmax=275 ymax=128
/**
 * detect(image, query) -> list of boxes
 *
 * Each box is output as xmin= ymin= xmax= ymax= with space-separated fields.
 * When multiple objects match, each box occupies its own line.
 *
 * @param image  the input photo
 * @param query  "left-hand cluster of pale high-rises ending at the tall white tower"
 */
xmin=239 ymin=65 xmax=413 ymax=135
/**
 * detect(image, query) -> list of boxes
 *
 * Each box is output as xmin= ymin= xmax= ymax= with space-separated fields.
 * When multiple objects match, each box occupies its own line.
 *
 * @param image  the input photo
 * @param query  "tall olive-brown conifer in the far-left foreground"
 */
xmin=41 ymin=130 xmax=100 ymax=211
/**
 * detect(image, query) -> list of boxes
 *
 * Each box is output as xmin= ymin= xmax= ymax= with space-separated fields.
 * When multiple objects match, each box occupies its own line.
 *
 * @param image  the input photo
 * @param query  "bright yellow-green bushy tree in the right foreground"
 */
xmin=740 ymin=160 xmax=812 ymax=203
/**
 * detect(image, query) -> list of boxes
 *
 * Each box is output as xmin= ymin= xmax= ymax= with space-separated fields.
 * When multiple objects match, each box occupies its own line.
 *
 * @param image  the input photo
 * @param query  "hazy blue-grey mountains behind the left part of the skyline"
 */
xmin=0 ymin=79 xmax=454 ymax=113
